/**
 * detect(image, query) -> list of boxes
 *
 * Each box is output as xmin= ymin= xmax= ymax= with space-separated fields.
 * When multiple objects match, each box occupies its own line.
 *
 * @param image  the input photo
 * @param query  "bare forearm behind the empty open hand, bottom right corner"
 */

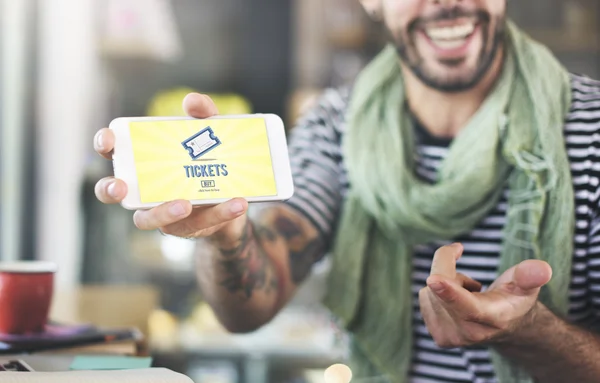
xmin=496 ymin=303 xmax=600 ymax=383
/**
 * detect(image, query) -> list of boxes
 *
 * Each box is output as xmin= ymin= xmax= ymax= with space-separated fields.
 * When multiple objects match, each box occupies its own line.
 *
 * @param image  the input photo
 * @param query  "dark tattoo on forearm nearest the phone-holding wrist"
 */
xmin=219 ymin=221 xmax=277 ymax=299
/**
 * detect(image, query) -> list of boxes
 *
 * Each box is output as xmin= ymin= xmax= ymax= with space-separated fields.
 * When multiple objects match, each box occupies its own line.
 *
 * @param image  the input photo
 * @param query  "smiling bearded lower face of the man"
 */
xmin=390 ymin=1 xmax=506 ymax=92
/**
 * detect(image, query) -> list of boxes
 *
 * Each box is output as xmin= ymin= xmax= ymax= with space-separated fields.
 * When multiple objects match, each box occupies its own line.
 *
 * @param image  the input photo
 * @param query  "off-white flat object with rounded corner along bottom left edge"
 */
xmin=0 ymin=368 xmax=194 ymax=383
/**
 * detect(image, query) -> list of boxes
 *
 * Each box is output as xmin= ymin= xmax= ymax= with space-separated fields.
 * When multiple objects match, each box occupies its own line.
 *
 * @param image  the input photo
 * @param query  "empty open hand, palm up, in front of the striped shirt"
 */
xmin=419 ymin=244 xmax=552 ymax=348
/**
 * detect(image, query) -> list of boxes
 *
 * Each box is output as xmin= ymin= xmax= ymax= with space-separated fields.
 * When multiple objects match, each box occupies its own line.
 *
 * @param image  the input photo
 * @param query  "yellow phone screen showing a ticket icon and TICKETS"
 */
xmin=129 ymin=118 xmax=277 ymax=203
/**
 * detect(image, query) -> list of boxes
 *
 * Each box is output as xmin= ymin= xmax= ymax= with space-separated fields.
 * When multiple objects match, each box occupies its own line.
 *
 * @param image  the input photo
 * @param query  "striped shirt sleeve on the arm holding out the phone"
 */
xmin=286 ymin=90 xmax=347 ymax=250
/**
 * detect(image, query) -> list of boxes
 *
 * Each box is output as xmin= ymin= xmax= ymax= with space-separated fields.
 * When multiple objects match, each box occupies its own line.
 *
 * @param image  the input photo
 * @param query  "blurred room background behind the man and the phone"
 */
xmin=0 ymin=0 xmax=600 ymax=383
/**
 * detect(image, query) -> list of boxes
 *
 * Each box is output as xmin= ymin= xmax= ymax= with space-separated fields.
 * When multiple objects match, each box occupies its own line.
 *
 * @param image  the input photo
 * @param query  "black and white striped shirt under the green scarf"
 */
xmin=288 ymin=75 xmax=600 ymax=383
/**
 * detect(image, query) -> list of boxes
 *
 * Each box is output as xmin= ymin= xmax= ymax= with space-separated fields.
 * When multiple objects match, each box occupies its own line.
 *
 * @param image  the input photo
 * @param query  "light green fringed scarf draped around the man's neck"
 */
xmin=325 ymin=22 xmax=575 ymax=383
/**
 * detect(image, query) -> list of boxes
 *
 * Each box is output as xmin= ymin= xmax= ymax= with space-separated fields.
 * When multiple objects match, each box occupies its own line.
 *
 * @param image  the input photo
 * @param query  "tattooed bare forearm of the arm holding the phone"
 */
xmin=196 ymin=204 xmax=322 ymax=332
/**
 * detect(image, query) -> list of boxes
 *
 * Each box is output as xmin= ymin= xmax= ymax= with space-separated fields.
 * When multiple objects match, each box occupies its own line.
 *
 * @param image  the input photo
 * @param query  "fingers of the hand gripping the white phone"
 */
xmin=94 ymin=93 xmax=248 ymax=243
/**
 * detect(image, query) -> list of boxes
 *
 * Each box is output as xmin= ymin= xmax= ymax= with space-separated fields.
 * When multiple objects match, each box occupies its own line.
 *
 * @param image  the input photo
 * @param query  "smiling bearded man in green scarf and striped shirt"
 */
xmin=96 ymin=0 xmax=600 ymax=383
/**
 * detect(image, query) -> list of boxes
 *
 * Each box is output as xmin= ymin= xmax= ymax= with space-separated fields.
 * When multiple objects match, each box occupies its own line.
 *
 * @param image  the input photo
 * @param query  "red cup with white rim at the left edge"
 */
xmin=0 ymin=261 xmax=56 ymax=335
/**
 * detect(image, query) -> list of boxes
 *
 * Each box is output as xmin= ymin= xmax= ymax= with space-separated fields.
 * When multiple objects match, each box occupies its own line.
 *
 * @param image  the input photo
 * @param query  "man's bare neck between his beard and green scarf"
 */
xmin=401 ymin=48 xmax=504 ymax=138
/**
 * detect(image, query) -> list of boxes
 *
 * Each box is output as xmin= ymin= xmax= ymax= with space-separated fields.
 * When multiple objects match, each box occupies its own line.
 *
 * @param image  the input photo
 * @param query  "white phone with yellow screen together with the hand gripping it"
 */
xmin=94 ymin=94 xmax=293 ymax=243
